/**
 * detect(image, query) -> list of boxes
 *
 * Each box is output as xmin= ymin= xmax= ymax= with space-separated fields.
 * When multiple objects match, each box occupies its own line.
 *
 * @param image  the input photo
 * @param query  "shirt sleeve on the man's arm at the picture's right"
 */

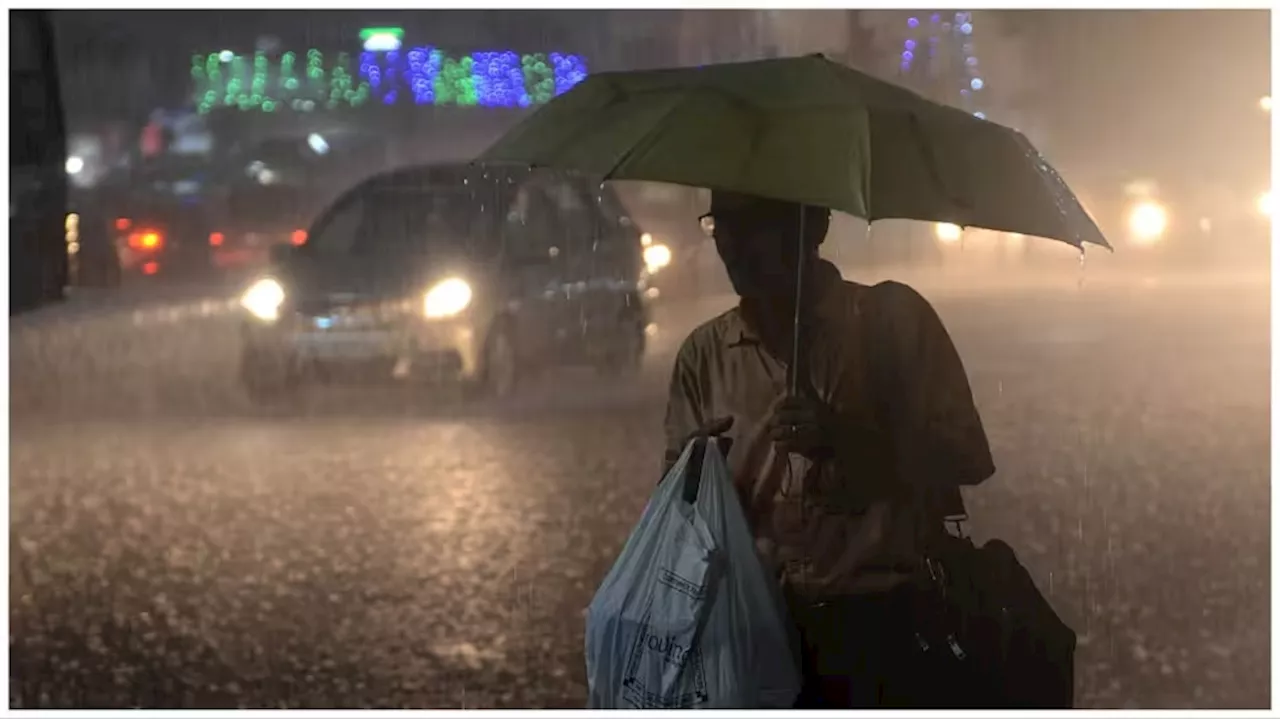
xmin=882 ymin=283 xmax=996 ymax=487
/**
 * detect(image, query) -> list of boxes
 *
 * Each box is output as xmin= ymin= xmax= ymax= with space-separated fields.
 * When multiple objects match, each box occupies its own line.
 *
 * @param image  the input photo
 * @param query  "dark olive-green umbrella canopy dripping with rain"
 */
xmin=479 ymin=55 xmax=1110 ymax=247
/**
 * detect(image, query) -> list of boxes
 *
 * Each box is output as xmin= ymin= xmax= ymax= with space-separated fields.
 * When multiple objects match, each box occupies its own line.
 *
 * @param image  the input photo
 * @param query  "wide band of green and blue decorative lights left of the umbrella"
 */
xmin=191 ymin=45 xmax=588 ymax=113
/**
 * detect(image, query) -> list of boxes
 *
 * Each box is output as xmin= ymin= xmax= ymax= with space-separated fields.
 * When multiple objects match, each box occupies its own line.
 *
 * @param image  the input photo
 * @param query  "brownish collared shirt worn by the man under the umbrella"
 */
xmin=666 ymin=264 xmax=995 ymax=600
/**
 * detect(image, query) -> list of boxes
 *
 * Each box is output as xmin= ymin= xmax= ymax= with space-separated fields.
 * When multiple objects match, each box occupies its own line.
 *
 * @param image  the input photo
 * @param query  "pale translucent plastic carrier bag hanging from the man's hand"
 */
xmin=586 ymin=440 xmax=800 ymax=709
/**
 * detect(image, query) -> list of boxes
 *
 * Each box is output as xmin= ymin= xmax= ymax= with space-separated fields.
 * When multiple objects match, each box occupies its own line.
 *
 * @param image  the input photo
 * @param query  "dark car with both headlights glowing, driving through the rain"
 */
xmin=241 ymin=158 xmax=649 ymax=400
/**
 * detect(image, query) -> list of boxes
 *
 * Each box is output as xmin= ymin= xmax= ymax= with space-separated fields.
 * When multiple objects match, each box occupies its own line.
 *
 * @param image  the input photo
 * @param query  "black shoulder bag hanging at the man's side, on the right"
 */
xmin=864 ymin=281 xmax=1076 ymax=709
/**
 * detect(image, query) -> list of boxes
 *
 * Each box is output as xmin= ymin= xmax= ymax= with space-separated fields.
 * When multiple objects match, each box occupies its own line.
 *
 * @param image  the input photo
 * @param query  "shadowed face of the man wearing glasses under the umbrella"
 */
xmin=709 ymin=195 xmax=826 ymax=301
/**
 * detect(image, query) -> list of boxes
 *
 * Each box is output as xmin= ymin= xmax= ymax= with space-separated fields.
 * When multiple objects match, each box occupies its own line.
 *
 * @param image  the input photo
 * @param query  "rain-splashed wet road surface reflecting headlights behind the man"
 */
xmin=10 ymin=278 xmax=1270 ymax=707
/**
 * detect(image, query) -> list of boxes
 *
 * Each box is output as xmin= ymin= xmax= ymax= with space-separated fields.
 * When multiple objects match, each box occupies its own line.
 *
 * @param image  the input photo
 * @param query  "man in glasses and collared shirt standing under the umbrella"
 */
xmin=666 ymin=192 xmax=995 ymax=709
